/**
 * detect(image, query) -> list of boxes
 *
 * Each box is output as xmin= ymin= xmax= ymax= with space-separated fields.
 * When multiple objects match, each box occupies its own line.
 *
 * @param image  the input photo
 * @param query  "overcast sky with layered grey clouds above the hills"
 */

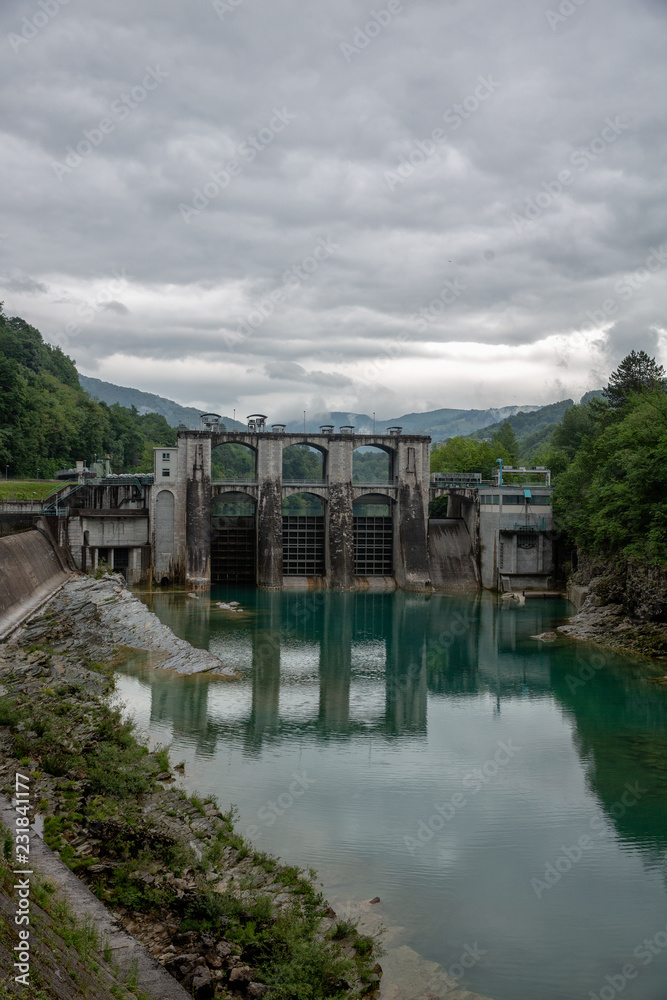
xmin=0 ymin=0 xmax=667 ymax=420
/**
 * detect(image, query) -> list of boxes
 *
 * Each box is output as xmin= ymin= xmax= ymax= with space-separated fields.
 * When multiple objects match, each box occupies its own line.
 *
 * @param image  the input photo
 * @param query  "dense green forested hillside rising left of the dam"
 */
xmin=0 ymin=303 xmax=176 ymax=479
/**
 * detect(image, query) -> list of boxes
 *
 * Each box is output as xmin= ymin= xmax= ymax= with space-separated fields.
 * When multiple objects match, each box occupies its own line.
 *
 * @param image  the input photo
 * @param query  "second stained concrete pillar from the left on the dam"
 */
xmin=257 ymin=435 xmax=283 ymax=589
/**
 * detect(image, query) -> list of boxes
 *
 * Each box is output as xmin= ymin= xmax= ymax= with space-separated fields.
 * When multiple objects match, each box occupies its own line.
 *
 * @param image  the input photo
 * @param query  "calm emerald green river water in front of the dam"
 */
xmin=119 ymin=588 xmax=667 ymax=1000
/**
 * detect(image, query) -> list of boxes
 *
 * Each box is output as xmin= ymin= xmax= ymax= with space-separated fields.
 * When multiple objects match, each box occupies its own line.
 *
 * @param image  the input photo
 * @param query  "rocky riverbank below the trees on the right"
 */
xmin=558 ymin=557 xmax=667 ymax=657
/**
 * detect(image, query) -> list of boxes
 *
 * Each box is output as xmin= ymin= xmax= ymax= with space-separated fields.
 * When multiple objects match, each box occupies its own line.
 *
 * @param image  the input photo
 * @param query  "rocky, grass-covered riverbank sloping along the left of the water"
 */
xmin=0 ymin=577 xmax=382 ymax=1000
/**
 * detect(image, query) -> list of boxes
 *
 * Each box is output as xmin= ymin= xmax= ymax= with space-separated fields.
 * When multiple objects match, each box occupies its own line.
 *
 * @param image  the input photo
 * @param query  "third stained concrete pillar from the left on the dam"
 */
xmin=326 ymin=435 xmax=355 ymax=590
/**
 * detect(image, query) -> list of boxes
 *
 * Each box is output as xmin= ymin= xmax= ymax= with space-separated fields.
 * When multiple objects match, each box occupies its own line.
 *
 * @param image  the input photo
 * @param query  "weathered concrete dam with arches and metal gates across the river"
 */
xmin=2 ymin=414 xmax=553 ymax=601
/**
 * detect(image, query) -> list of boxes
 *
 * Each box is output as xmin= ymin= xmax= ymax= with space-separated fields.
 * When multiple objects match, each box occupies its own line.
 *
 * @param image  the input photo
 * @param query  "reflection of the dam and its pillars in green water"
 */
xmin=144 ymin=592 xmax=550 ymax=753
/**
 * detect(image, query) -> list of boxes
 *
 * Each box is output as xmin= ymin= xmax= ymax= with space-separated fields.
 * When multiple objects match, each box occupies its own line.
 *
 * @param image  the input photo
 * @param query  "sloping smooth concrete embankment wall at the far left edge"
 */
xmin=0 ymin=528 xmax=69 ymax=639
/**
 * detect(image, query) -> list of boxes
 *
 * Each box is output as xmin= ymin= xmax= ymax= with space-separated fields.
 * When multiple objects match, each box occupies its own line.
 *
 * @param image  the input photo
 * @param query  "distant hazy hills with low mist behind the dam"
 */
xmin=79 ymin=375 xmax=572 ymax=441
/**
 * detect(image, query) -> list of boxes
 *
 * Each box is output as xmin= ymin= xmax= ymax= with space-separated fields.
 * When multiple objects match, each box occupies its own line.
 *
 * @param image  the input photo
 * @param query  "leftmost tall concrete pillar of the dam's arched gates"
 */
xmin=185 ymin=438 xmax=211 ymax=587
